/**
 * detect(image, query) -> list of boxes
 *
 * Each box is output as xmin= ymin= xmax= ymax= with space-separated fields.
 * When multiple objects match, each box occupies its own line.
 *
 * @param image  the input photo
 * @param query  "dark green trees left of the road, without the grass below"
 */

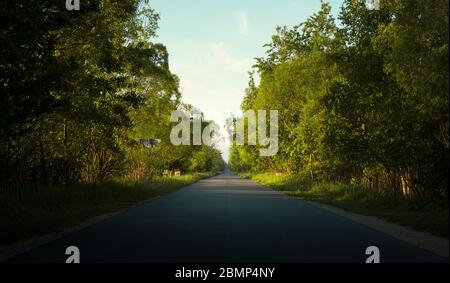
xmin=0 ymin=0 xmax=221 ymax=191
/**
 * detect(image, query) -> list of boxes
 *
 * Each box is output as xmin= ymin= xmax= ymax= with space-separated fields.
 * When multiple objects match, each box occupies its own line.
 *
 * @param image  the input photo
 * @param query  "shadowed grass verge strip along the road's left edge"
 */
xmin=0 ymin=173 xmax=215 ymax=246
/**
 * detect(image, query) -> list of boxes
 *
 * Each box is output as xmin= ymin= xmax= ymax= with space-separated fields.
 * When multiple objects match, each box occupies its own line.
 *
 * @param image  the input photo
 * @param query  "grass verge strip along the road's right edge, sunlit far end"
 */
xmin=242 ymin=173 xmax=449 ymax=238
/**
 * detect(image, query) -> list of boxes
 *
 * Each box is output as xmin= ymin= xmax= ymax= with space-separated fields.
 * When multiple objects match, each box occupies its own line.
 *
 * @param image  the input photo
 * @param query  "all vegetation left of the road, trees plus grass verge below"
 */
xmin=0 ymin=0 xmax=224 ymax=244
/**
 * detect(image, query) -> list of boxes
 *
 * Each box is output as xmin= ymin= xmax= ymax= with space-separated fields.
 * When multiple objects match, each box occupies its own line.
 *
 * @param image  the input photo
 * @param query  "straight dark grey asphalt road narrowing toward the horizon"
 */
xmin=10 ymin=174 xmax=448 ymax=263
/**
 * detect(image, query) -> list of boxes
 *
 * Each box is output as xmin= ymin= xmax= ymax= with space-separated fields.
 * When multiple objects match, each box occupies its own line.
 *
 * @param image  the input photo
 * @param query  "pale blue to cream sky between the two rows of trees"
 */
xmin=150 ymin=0 xmax=343 ymax=160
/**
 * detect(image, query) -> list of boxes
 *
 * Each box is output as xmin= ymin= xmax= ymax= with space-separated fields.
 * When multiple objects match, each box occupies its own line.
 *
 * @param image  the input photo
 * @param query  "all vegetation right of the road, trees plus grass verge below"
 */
xmin=229 ymin=0 xmax=449 ymax=237
